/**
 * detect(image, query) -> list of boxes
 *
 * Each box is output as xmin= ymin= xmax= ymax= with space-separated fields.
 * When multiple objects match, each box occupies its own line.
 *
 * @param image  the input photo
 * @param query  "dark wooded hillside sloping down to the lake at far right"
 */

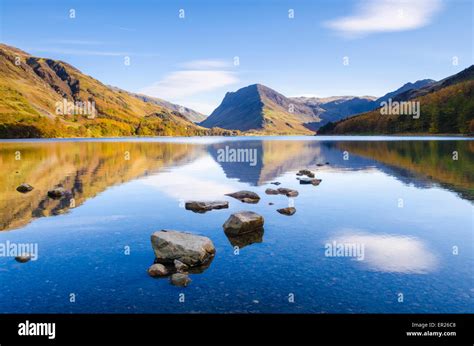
xmin=318 ymin=65 xmax=474 ymax=134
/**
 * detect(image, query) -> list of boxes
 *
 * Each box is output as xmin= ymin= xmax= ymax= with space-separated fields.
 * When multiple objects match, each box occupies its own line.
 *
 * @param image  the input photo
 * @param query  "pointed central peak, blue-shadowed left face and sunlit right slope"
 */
xmin=200 ymin=84 xmax=319 ymax=134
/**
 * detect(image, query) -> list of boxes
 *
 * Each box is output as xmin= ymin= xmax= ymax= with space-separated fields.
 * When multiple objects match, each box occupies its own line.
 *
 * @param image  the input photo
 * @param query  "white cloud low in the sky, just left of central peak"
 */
xmin=140 ymin=70 xmax=239 ymax=100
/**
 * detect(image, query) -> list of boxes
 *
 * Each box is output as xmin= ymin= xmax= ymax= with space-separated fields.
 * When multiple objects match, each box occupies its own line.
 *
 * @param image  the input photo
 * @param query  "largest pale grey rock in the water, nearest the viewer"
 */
xmin=151 ymin=230 xmax=216 ymax=267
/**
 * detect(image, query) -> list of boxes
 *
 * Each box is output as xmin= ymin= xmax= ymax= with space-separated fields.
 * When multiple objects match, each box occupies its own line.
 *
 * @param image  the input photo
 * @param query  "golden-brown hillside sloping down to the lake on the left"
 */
xmin=0 ymin=44 xmax=231 ymax=138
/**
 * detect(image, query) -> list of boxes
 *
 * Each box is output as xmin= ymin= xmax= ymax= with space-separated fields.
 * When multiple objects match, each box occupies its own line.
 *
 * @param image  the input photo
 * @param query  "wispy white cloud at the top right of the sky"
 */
xmin=326 ymin=0 xmax=441 ymax=37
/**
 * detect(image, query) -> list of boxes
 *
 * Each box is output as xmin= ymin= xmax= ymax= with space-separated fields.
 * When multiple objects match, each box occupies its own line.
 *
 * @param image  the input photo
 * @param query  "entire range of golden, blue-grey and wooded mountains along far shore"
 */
xmin=0 ymin=44 xmax=474 ymax=138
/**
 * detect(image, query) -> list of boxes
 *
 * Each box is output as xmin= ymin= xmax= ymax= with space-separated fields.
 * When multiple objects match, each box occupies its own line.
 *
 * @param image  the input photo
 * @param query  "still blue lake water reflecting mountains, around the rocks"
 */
xmin=0 ymin=137 xmax=474 ymax=313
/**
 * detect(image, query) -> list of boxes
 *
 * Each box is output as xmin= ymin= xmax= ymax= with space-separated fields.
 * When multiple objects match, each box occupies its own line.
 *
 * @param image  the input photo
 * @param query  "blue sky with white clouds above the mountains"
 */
xmin=0 ymin=0 xmax=474 ymax=114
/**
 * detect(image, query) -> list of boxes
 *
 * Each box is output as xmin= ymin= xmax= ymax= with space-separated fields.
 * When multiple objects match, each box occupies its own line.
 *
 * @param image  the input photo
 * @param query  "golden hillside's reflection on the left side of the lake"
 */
xmin=0 ymin=142 xmax=203 ymax=230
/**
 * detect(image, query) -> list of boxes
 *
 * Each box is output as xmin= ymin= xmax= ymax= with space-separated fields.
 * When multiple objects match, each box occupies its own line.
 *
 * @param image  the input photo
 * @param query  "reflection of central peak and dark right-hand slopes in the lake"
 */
xmin=208 ymin=140 xmax=474 ymax=200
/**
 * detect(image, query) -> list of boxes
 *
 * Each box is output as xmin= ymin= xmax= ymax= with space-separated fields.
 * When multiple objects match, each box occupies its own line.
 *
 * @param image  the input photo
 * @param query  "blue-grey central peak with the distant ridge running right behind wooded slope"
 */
xmin=200 ymin=79 xmax=462 ymax=135
